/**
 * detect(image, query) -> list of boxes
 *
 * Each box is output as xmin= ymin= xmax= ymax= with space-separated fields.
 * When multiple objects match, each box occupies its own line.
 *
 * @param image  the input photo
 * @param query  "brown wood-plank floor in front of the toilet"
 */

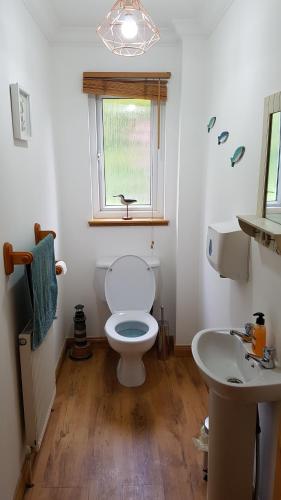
xmin=25 ymin=347 xmax=207 ymax=500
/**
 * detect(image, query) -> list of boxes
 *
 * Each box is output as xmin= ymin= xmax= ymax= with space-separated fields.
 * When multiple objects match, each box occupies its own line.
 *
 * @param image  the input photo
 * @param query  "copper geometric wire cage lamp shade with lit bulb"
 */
xmin=97 ymin=0 xmax=160 ymax=57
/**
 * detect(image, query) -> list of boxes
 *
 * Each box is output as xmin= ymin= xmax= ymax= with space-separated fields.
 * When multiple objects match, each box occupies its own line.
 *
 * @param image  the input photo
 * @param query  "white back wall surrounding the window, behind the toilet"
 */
xmin=53 ymin=44 xmax=181 ymax=336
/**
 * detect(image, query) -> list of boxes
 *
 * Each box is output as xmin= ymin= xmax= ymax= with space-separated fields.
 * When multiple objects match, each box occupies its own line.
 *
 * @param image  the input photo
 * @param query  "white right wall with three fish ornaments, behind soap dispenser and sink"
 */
xmin=200 ymin=0 xmax=281 ymax=358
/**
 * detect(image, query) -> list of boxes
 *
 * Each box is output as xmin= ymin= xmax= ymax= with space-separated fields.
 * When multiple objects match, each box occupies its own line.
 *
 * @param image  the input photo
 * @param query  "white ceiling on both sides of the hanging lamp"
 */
xmin=23 ymin=0 xmax=233 ymax=42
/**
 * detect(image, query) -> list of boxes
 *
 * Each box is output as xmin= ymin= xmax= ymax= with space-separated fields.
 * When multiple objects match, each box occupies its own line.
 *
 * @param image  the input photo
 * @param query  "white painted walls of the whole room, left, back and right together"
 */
xmin=4 ymin=0 xmax=281 ymax=500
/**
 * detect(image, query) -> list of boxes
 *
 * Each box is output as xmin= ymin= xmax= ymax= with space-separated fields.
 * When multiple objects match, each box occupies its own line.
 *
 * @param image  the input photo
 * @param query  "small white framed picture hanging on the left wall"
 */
xmin=10 ymin=83 xmax=31 ymax=141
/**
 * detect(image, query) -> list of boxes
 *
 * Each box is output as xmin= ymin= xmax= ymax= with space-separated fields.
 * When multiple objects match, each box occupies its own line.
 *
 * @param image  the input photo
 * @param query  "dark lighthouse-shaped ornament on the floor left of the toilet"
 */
xmin=70 ymin=304 xmax=92 ymax=361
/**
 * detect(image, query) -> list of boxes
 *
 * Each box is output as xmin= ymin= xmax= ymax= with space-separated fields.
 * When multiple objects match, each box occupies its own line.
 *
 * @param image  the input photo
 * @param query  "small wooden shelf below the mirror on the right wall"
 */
xmin=237 ymin=215 xmax=281 ymax=254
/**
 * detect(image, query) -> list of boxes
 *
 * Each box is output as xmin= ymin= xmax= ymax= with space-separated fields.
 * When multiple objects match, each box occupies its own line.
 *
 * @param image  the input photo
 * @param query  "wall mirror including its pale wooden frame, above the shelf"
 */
xmin=260 ymin=92 xmax=281 ymax=224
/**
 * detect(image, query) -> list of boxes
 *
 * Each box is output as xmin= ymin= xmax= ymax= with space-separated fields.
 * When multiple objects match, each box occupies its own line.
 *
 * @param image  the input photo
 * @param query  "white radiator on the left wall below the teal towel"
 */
xmin=19 ymin=323 xmax=56 ymax=450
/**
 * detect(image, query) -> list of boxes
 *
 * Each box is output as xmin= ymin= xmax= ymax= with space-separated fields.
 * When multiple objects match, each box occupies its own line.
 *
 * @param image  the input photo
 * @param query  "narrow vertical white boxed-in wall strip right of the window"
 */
xmin=176 ymin=36 xmax=206 ymax=345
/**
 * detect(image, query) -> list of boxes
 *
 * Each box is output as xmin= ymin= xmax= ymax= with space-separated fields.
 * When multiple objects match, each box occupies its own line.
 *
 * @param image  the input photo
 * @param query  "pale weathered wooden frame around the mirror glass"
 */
xmin=257 ymin=92 xmax=281 ymax=220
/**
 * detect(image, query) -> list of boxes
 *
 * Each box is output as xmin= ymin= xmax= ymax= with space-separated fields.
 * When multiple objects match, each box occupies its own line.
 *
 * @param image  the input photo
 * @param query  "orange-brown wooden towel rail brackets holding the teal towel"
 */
xmin=3 ymin=223 xmax=63 ymax=276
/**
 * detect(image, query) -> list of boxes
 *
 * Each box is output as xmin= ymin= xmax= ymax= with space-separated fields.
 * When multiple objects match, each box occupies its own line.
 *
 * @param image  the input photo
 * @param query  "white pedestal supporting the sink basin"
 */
xmin=207 ymin=390 xmax=257 ymax=500
